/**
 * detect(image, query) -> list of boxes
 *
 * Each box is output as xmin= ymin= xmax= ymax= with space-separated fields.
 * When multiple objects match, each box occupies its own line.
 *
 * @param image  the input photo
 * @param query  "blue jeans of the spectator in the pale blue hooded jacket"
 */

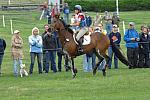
xmin=29 ymin=52 xmax=42 ymax=74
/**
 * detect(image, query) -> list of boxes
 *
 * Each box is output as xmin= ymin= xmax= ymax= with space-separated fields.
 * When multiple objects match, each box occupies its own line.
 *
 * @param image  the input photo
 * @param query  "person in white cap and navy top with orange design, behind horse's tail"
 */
xmin=108 ymin=24 xmax=121 ymax=69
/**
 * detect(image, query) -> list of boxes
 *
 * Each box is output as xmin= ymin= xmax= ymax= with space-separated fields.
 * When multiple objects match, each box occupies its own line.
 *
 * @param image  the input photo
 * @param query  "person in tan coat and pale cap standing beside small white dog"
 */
xmin=11 ymin=30 xmax=23 ymax=76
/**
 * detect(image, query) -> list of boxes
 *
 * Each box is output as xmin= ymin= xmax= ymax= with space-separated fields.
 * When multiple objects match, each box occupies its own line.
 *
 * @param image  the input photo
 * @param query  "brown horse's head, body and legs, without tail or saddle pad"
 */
xmin=52 ymin=16 xmax=129 ymax=78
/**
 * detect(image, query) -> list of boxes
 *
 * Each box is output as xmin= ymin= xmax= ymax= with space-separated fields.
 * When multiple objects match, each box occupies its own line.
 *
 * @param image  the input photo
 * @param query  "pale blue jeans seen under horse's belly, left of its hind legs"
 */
xmin=83 ymin=54 xmax=92 ymax=72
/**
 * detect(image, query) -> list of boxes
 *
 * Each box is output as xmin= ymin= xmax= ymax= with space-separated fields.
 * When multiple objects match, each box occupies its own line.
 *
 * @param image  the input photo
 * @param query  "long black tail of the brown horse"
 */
xmin=112 ymin=44 xmax=130 ymax=66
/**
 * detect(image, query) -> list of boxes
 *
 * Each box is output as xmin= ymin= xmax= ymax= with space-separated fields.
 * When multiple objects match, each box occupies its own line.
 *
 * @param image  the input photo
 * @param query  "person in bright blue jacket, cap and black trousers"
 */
xmin=124 ymin=22 xmax=139 ymax=69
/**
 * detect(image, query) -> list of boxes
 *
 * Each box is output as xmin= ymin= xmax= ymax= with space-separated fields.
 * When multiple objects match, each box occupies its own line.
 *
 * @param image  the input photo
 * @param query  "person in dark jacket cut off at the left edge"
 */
xmin=0 ymin=38 xmax=6 ymax=76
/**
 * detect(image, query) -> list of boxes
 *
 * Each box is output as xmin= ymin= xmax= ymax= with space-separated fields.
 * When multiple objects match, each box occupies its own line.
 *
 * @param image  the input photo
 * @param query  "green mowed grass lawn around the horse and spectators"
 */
xmin=0 ymin=11 xmax=150 ymax=100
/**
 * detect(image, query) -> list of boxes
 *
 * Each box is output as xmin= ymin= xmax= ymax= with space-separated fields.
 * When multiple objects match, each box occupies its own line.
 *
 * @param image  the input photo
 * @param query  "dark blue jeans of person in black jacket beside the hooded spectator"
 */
xmin=45 ymin=50 xmax=57 ymax=73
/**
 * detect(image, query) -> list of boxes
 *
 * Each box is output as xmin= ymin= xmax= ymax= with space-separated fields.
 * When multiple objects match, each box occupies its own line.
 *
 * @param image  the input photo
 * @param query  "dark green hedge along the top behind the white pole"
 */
xmin=65 ymin=0 xmax=150 ymax=12
